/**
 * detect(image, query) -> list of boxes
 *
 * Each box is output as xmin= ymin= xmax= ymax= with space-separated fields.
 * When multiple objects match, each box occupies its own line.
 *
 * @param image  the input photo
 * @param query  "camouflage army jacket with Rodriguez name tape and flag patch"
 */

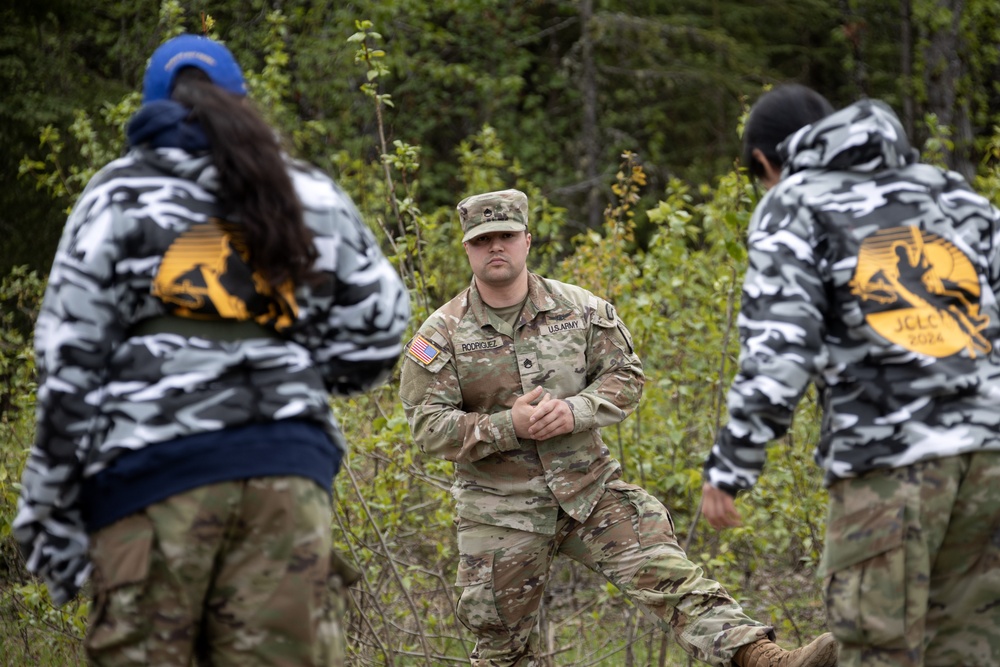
xmin=400 ymin=274 xmax=643 ymax=535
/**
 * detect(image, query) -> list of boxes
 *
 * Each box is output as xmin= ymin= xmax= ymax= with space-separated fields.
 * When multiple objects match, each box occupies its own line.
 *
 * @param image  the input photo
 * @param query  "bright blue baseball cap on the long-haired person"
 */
xmin=142 ymin=35 xmax=247 ymax=104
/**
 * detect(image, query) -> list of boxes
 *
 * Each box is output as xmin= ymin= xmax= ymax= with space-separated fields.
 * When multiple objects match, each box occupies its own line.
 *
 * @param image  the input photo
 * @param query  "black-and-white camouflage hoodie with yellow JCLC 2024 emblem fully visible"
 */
xmin=705 ymin=100 xmax=1000 ymax=493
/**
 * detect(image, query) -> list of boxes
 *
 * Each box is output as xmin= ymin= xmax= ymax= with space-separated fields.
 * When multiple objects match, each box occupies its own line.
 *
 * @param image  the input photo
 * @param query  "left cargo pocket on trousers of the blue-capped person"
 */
xmin=85 ymin=513 xmax=153 ymax=655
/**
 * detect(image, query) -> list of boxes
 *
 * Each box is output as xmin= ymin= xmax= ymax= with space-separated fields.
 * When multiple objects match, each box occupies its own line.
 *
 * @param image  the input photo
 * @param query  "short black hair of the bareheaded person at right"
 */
xmin=743 ymin=83 xmax=834 ymax=178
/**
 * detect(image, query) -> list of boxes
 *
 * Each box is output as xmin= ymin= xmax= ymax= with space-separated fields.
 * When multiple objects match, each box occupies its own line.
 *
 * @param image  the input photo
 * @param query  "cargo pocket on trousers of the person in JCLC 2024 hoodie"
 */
xmin=820 ymin=503 xmax=907 ymax=649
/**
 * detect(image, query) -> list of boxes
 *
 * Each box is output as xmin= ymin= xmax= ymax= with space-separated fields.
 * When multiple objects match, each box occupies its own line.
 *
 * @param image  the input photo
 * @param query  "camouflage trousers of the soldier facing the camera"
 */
xmin=456 ymin=481 xmax=773 ymax=667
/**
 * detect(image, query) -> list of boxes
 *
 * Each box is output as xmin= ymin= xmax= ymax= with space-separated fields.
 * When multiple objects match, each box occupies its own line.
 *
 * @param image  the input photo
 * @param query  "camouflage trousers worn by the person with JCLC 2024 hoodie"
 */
xmin=821 ymin=452 xmax=1000 ymax=667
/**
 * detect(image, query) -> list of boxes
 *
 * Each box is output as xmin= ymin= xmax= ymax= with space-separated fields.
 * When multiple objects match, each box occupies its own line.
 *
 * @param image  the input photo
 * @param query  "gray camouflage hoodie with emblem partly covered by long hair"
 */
xmin=13 ymin=148 xmax=409 ymax=602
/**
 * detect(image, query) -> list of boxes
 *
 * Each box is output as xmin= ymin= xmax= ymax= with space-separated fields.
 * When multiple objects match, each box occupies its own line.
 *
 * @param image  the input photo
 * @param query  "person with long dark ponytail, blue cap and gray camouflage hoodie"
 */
xmin=13 ymin=35 xmax=409 ymax=667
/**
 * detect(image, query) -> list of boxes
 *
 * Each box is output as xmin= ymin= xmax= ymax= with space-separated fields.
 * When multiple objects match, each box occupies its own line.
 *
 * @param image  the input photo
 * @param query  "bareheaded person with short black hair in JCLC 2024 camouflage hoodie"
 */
xmin=704 ymin=89 xmax=1000 ymax=667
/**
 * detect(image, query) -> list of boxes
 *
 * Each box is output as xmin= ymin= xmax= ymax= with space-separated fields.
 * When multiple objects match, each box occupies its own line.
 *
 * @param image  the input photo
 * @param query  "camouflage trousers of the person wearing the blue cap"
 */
xmin=85 ymin=477 xmax=354 ymax=667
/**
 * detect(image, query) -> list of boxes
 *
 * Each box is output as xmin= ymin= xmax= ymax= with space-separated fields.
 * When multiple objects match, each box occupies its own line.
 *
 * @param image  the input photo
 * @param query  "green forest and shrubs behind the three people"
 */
xmin=0 ymin=0 xmax=1000 ymax=667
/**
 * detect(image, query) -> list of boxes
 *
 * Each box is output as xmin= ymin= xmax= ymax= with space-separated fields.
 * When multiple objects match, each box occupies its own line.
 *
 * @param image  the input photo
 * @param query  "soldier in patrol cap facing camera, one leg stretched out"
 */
xmin=400 ymin=190 xmax=836 ymax=667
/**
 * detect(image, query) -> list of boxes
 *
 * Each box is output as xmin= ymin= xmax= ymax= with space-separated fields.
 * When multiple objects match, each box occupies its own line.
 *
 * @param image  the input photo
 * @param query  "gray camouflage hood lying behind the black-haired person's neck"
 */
xmin=778 ymin=99 xmax=919 ymax=177
